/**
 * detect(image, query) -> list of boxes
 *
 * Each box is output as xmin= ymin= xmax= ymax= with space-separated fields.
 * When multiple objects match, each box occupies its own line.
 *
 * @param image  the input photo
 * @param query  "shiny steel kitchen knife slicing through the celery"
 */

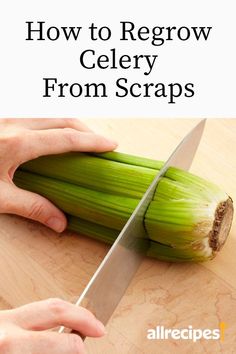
xmin=59 ymin=119 xmax=206 ymax=339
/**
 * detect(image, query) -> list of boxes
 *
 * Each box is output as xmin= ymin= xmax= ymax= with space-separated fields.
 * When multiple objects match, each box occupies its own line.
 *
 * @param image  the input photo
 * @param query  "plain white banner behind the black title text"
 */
xmin=0 ymin=0 xmax=236 ymax=118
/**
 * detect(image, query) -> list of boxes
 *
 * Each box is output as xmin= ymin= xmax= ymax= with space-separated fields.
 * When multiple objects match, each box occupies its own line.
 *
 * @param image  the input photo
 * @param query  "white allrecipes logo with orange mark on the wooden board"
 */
xmin=147 ymin=322 xmax=225 ymax=342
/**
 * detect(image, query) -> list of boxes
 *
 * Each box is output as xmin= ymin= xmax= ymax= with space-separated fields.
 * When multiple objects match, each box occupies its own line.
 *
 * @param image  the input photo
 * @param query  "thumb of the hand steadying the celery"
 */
xmin=1 ymin=185 xmax=67 ymax=232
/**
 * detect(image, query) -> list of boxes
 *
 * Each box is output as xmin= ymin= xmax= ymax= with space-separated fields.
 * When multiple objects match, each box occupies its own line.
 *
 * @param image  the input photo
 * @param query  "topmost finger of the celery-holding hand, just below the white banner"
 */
xmin=1 ymin=118 xmax=92 ymax=132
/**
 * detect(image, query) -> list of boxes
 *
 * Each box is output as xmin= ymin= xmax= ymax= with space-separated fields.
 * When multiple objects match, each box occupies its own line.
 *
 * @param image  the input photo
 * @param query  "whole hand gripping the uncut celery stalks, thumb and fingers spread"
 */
xmin=0 ymin=119 xmax=116 ymax=232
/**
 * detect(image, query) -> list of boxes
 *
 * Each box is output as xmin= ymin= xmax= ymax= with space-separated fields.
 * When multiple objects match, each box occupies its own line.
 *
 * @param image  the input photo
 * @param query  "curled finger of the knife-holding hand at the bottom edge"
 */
xmin=27 ymin=332 xmax=85 ymax=354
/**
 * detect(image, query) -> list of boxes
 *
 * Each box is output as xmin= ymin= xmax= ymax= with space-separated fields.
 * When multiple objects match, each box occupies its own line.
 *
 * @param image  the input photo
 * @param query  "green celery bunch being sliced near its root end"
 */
xmin=14 ymin=152 xmax=233 ymax=261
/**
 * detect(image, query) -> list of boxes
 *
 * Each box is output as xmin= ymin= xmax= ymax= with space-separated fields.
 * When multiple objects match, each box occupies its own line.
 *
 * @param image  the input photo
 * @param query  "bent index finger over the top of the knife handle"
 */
xmin=11 ymin=299 xmax=104 ymax=337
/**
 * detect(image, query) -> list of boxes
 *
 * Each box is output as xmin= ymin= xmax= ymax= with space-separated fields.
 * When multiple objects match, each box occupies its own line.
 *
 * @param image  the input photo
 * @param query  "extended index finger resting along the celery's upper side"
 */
xmin=18 ymin=128 xmax=117 ymax=163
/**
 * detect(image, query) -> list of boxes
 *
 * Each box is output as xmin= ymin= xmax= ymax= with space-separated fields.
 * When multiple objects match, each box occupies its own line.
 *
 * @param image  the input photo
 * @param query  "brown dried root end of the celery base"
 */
xmin=209 ymin=198 xmax=234 ymax=254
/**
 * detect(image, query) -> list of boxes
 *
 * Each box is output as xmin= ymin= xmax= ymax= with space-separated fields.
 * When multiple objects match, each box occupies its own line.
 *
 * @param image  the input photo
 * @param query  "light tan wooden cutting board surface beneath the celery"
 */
xmin=0 ymin=119 xmax=236 ymax=354
